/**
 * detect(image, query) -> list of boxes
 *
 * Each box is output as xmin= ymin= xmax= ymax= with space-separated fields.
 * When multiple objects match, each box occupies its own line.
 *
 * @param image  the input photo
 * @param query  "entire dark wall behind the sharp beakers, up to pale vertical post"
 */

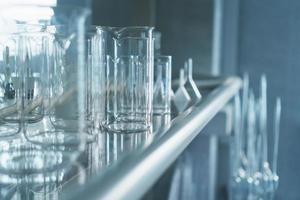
xmin=92 ymin=0 xmax=213 ymax=77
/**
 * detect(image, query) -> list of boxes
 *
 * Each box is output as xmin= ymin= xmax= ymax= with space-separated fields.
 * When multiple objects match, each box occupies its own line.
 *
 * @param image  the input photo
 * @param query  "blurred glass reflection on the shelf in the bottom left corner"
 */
xmin=0 ymin=163 xmax=85 ymax=200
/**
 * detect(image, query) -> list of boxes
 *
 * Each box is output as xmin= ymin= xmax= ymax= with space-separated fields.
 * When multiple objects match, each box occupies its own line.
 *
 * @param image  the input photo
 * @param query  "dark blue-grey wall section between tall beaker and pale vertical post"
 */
xmin=155 ymin=0 xmax=213 ymax=77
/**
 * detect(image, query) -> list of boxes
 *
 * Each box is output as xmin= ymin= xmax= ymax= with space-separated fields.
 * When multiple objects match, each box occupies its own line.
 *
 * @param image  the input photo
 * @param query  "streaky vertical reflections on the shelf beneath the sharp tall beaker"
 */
xmin=81 ymin=114 xmax=171 ymax=174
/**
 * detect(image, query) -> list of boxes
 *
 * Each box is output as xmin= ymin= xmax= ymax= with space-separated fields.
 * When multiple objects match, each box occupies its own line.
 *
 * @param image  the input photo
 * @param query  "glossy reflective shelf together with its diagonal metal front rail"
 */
xmin=0 ymin=77 xmax=241 ymax=200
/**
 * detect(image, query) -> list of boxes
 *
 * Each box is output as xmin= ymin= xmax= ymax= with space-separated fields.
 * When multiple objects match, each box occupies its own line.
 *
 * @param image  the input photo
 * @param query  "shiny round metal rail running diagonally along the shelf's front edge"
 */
xmin=64 ymin=77 xmax=241 ymax=200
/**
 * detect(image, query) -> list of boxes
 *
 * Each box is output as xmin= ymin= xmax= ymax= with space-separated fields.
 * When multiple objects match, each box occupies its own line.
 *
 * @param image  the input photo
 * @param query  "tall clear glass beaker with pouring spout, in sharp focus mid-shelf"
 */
xmin=97 ymin=27 xmax=154 ymax=133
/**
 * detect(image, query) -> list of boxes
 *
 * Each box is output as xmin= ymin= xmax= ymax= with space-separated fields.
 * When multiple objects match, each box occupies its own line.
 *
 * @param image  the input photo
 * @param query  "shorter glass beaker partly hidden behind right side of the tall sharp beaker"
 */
xmin=153 ymin=56 xmax=172 ymax=115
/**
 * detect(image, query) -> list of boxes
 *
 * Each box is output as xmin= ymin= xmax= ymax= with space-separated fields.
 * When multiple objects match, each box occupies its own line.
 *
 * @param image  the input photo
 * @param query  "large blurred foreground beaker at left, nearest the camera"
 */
xmin=0 ymin=5 xmax=89 ymax=176
